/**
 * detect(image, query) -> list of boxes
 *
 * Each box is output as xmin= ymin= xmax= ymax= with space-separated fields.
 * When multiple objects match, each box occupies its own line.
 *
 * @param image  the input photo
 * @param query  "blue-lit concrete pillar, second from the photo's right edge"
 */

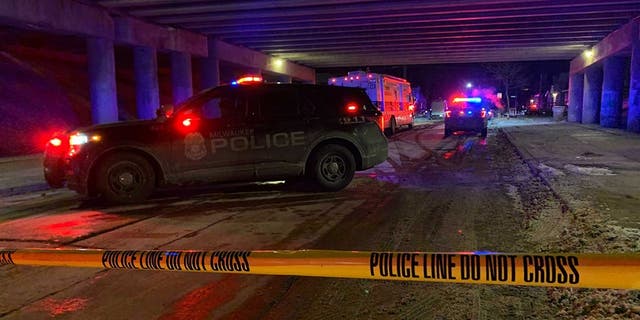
xmin=600 ymin=57 xmax=625 ymax=128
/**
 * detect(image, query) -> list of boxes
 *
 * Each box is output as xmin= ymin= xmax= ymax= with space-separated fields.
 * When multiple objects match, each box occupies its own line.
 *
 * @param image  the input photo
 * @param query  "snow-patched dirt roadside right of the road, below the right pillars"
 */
xmin=501 ymin=123 xmax=640 ymax=319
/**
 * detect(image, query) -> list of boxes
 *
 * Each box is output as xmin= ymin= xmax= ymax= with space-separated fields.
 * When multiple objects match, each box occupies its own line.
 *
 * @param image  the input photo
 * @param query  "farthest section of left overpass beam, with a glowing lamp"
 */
xmin=209 ymin=39 xmax=316 ymax=83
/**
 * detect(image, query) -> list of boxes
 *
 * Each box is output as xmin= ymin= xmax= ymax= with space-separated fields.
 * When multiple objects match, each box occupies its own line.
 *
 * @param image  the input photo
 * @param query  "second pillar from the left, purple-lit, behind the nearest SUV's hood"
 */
xmin=133 ymin=47 xmax=160 ymax=120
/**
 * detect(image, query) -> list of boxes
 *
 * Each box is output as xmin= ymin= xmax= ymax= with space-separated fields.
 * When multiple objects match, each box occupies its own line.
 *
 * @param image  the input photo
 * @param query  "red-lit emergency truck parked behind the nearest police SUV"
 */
xmin=329 ymin=71 xmax=414 ymax=135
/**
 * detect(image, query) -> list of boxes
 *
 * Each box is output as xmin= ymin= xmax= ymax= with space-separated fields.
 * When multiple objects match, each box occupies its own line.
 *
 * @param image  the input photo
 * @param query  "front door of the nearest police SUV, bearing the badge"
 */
xmin=173 ymin=87 xmax=254 ymax=181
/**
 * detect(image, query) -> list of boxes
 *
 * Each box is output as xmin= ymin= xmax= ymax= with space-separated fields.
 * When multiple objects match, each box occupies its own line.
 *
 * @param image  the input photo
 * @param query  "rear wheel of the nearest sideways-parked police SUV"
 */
xmin=310 ymin=144 xmax=356 ymax=191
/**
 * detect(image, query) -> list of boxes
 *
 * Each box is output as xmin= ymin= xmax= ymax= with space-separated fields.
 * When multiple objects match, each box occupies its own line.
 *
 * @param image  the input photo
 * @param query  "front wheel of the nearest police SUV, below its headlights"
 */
xmin=96 ymin=153 xmax=156 ymax=203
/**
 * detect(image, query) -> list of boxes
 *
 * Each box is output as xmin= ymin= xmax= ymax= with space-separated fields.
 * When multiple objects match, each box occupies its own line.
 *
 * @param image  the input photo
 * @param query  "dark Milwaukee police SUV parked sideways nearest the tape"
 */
xmin=44 ymin=77 xmax=387 ymax=203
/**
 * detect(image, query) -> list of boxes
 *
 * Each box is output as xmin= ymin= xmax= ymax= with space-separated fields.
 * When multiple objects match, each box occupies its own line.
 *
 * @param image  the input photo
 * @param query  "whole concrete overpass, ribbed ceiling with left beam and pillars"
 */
xmin=0 ymin=0 xmax=640 ymax=130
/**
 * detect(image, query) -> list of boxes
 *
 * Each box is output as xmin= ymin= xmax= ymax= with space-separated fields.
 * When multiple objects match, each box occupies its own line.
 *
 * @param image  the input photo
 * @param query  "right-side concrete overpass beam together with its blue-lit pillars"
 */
xmin=569 ymin=18 xmax=640 ymax=132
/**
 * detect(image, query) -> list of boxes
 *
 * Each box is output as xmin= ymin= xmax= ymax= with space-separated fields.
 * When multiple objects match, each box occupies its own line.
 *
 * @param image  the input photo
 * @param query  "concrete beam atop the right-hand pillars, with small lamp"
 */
xmin=569 ymin=18 xmax=640 ymax=74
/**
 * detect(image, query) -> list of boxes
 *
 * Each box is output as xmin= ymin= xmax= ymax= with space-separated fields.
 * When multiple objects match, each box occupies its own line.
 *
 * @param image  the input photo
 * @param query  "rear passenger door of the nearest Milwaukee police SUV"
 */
xmin=256 ymin=85 xmax=308 ymax=179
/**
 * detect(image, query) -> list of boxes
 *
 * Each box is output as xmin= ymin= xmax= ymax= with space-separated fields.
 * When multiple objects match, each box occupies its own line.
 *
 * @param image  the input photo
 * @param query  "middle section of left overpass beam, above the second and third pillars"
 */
xmin=114 ymin=17 xmax=208 ymax=57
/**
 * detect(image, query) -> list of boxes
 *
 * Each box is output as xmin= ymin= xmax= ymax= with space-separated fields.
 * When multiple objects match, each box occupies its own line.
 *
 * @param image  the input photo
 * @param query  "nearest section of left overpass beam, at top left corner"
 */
xmin=0 ymin=0 xmax=113 ymax=39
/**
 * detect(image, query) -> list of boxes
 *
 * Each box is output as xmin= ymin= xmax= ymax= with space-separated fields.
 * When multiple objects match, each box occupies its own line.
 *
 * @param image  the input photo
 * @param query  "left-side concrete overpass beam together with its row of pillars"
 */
xmin=0 ymin=0 xmax=315 ymax=123
